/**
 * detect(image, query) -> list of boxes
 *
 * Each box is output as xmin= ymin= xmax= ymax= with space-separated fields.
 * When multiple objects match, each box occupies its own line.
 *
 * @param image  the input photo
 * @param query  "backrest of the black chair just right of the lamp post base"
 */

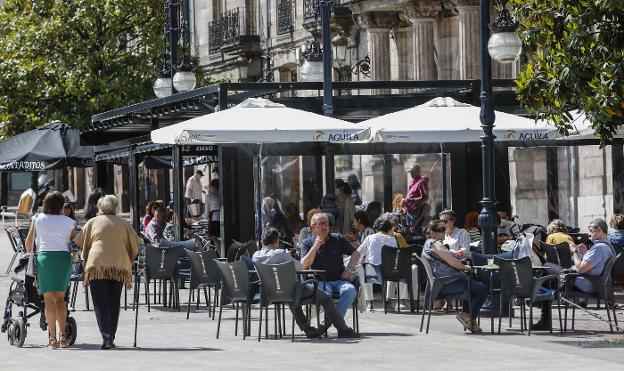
xmin=494 ymin=256 xmax=534 ymax=297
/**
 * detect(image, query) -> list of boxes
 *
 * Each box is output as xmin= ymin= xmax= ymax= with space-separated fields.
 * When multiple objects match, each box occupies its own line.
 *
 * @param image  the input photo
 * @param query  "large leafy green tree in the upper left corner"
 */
xmin=0 ymin=0 xmax=210 ymax=137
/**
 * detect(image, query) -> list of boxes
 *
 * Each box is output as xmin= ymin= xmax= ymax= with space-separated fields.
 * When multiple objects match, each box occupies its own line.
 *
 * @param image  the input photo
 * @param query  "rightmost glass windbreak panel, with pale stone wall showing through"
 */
xmin=557 ymin=146 xmax=613 ymax=232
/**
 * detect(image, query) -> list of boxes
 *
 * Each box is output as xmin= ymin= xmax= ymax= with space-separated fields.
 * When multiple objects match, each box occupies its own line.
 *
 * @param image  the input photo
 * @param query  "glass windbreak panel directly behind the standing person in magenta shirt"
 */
xmin=392 ymin=153 xmax=453 ymax=225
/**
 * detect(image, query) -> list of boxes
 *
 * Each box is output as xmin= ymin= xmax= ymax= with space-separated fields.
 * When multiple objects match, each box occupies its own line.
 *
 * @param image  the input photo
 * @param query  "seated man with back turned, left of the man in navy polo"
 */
xmin=252 ymin=228 xmax=359 ymax=338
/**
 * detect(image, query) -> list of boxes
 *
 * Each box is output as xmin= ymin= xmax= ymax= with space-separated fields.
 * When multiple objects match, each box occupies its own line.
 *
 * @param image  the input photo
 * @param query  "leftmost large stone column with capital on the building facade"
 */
xmin=359 ymin=12 xmax=399 ymax=94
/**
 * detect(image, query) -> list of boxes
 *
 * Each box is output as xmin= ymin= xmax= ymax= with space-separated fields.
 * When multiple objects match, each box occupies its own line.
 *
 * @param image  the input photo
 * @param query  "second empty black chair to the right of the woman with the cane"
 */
xmin=186 ymin=250 xmax=221 ymax=320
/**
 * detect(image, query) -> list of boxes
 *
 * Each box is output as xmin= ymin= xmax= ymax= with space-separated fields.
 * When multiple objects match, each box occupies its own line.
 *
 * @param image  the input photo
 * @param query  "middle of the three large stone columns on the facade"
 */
xmin=404 ymin=1 xmax=441 ymax=80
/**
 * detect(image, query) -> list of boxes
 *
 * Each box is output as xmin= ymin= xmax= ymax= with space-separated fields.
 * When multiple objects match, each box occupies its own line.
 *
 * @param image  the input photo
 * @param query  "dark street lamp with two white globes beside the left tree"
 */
xmin=154 ymin=0 xmax=196 ymax=98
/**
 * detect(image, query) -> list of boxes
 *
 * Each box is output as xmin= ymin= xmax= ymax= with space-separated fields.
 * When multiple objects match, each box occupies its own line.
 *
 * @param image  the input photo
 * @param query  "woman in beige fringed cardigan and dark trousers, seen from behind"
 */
xmin=76 ymin=195 xmax=140 ymax=349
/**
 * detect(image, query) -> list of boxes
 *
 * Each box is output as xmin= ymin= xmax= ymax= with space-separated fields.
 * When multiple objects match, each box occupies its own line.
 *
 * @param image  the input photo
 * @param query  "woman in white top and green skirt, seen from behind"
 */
xmin=26 ymin=192 xmax=76 ymax=349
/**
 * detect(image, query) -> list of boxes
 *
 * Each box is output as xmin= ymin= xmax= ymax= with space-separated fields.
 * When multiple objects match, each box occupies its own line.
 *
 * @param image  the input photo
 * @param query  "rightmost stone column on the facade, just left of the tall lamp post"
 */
xmin=457 ymin=0 xmax=481 ymax=79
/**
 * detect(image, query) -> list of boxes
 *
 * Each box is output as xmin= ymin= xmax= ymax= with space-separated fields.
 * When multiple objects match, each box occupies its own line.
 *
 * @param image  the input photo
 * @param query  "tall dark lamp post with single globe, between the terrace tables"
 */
xmin=479 ymin=0 xmax=522 ymax=254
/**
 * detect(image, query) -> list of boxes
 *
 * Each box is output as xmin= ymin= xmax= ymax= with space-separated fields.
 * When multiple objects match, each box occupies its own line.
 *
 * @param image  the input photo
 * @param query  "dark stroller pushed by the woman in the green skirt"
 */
xmin=0 ymin=255 xmax=77 ymax=347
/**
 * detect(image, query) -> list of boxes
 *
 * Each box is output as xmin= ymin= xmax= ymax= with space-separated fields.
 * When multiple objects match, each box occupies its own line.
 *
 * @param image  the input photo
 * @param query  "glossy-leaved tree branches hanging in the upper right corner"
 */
xmin=511 ymin=0 xmax=624 ymax=144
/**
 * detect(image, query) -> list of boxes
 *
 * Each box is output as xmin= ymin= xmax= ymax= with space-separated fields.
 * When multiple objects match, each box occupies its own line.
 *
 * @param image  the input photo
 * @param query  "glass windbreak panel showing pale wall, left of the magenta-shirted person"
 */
xmin=334 ymin=155 xmax=384 ymax=207
